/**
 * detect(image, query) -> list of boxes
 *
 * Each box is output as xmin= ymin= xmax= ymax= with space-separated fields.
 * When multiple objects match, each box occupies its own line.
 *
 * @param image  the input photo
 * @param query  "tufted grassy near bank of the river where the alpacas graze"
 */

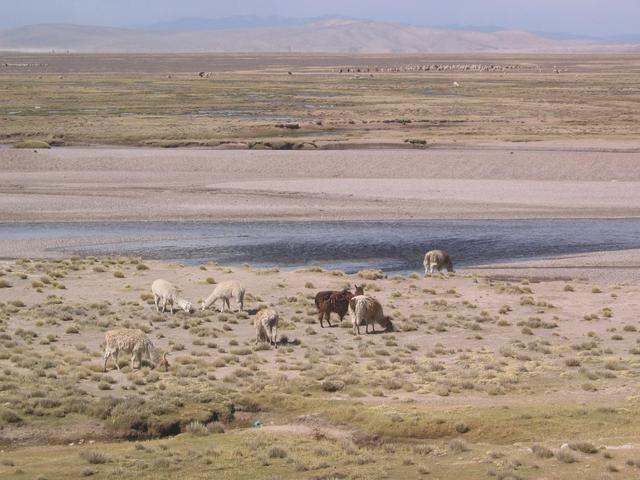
xmin=0 ymin=257 xmax=640 ymax=480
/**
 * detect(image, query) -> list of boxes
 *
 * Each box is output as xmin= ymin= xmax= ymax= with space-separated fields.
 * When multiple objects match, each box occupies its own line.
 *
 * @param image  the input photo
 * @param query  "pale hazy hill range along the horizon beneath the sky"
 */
xmin=0 ymin=17 xmax=637 ymax=53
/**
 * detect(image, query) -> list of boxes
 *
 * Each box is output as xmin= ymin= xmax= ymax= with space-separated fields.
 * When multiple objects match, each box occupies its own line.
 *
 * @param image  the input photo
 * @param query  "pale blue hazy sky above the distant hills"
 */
xmin=0 ymin=0 xmax=640 ymax=35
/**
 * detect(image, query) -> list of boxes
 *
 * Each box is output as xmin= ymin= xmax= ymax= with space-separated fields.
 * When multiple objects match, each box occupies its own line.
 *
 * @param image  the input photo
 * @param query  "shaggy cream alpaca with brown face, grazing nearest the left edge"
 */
xmin=104 ymin=328 xmax=169 ymax=372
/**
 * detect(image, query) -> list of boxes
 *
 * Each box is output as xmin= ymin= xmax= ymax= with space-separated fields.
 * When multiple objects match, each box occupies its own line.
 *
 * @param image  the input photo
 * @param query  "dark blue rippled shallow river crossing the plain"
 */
xmin=0 ymin=219 xmax=640 ymax=273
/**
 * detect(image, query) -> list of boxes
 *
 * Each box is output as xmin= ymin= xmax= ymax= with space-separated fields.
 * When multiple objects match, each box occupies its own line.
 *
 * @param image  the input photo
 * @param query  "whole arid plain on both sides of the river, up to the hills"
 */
xmin=0 ymin=54 xmax=640 ymax=480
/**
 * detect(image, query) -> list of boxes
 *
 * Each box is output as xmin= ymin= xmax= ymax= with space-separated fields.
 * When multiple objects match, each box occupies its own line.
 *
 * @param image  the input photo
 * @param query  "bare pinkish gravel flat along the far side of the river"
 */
xmin=0 ymin=141 xmax=640 ymax=222
